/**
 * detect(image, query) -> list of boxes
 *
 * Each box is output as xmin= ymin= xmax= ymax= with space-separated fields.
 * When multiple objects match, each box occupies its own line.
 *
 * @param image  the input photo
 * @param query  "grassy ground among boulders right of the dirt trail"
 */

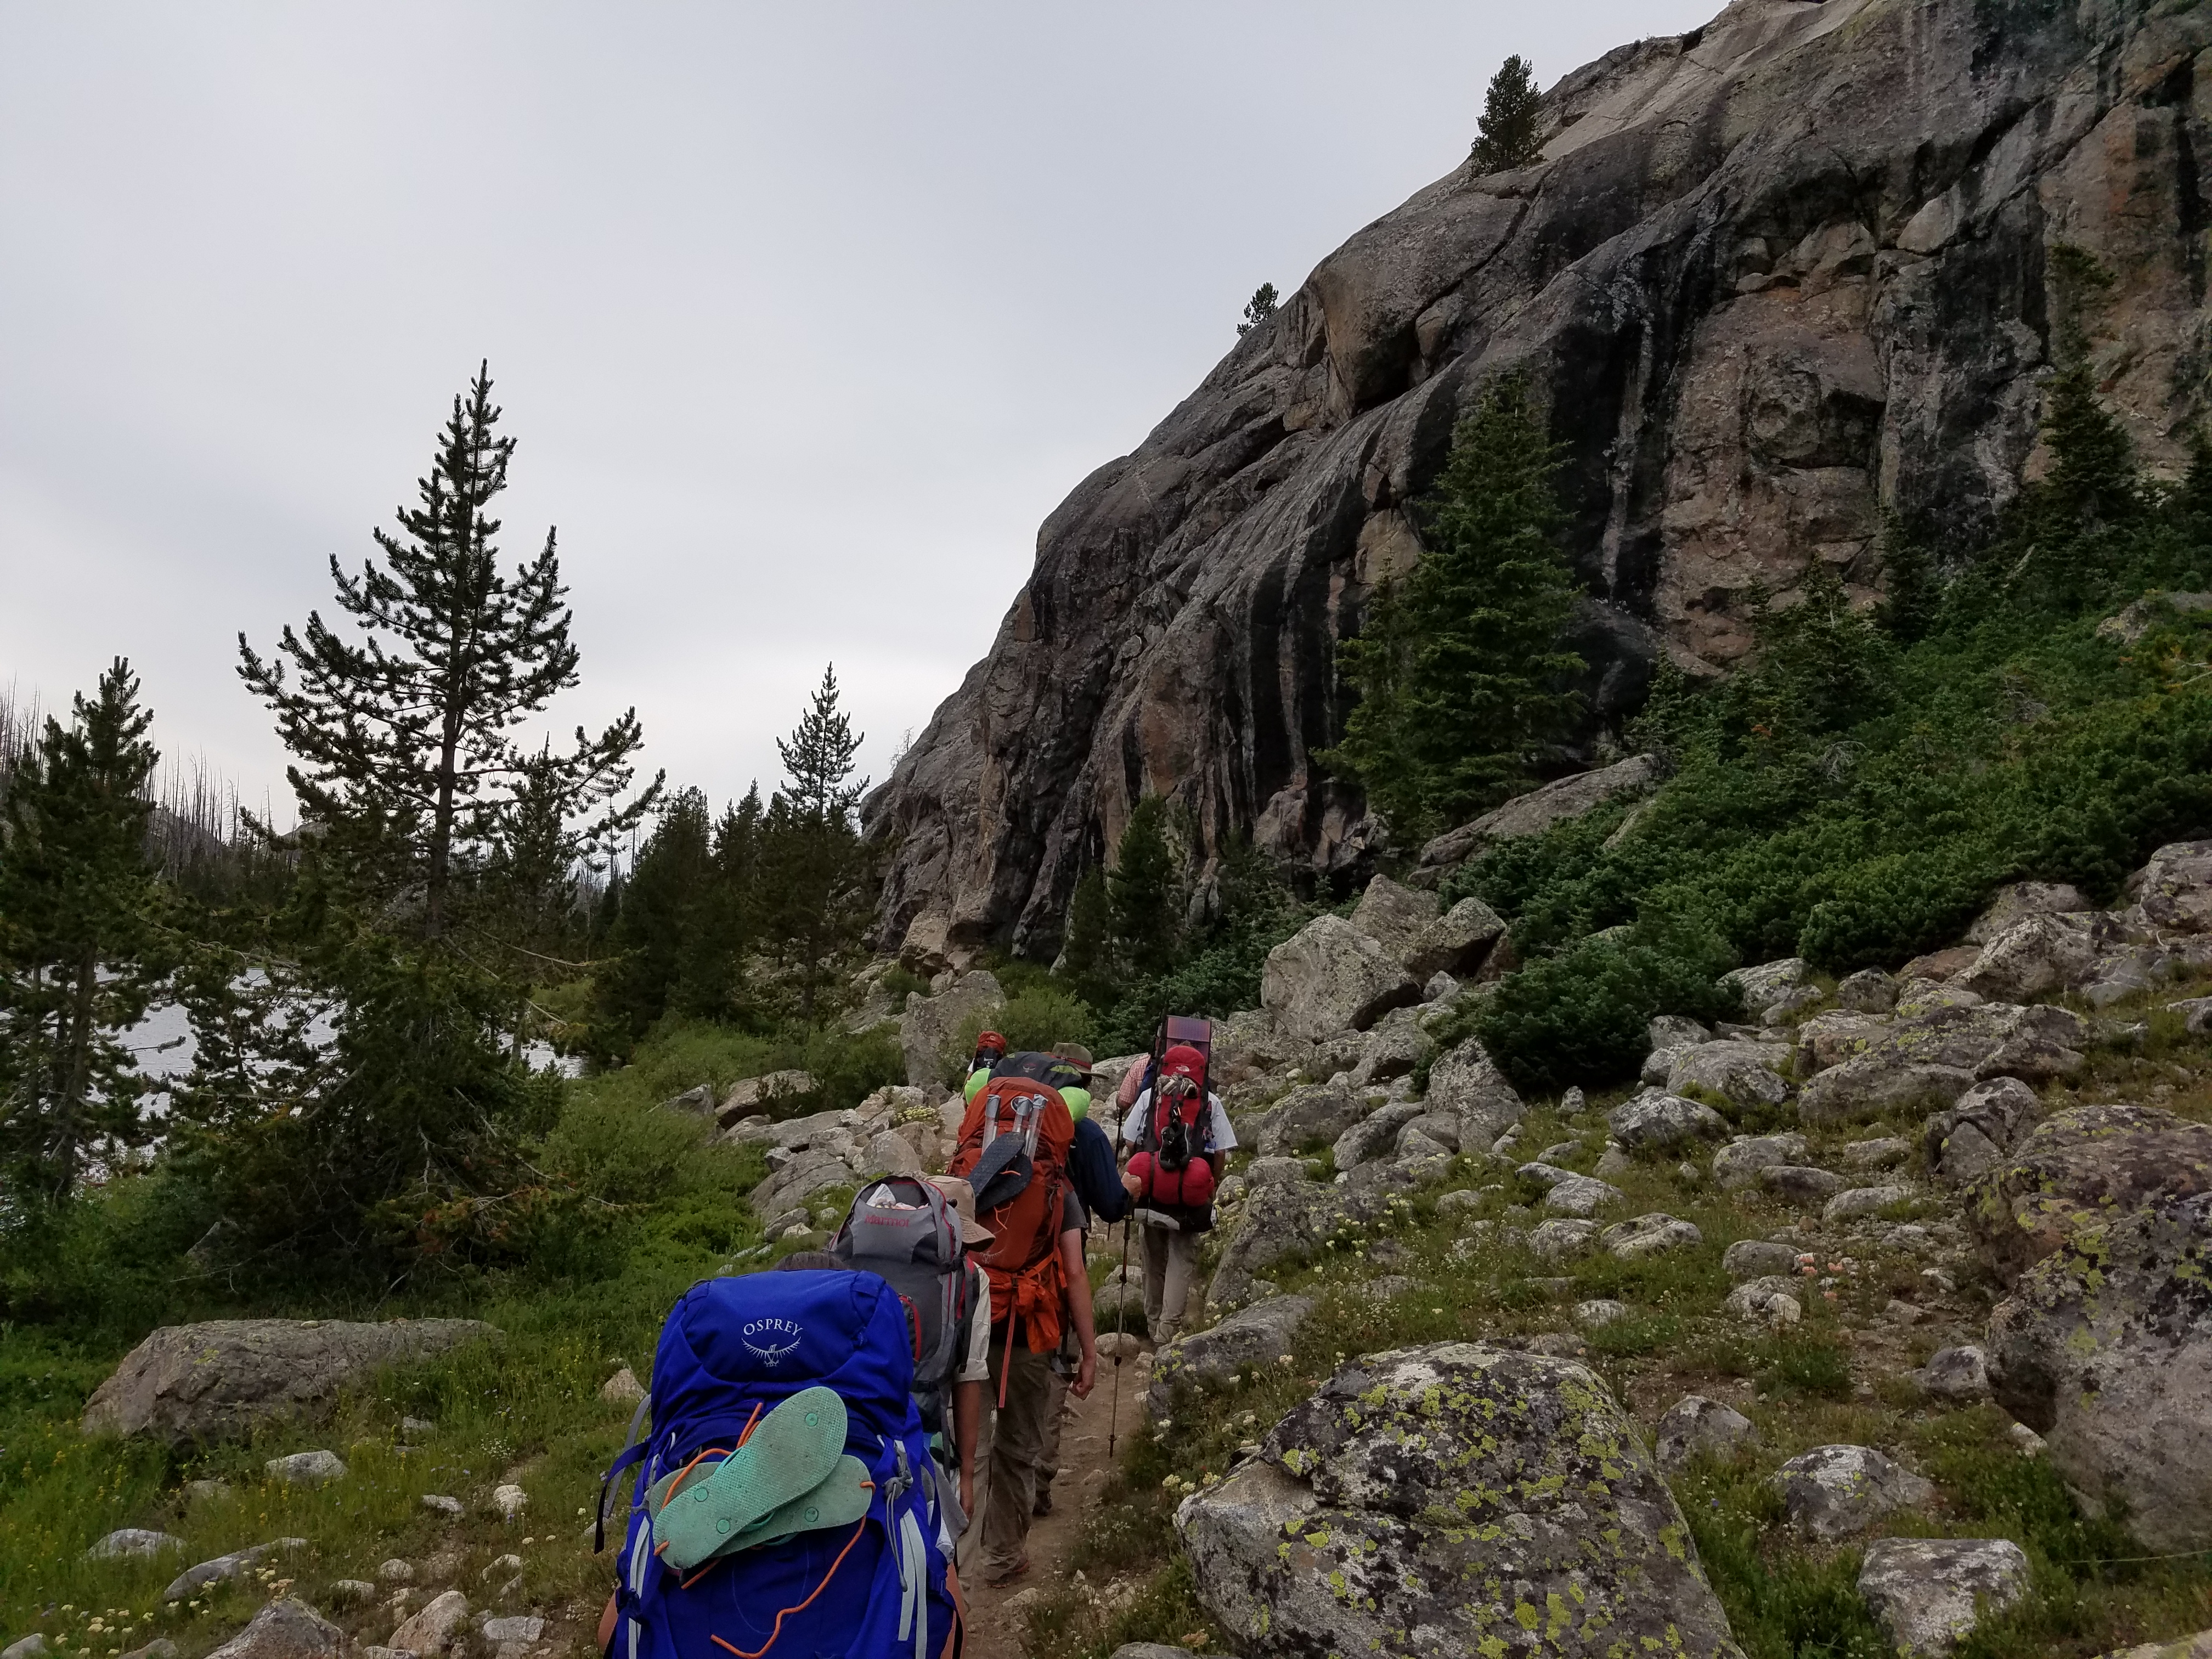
xmin=1031 ymin=986 xmax=2212 ymax=1659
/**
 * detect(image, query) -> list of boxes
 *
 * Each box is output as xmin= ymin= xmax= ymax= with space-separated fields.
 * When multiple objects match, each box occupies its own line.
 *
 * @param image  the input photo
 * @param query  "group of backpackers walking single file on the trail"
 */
xmin=600 ymin=1020 xmax=1237 ymax=1659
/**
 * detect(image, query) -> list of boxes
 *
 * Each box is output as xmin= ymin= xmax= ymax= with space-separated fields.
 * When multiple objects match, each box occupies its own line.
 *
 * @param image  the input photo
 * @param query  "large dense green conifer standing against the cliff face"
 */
xmin=1321 ymin=376 xmax=1584 ymax=840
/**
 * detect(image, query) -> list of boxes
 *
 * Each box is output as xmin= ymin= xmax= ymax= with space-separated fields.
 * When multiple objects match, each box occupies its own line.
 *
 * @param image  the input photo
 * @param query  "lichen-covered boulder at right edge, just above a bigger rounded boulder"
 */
xmin=1966 ymin=1106 xmax=2212 ymax=1281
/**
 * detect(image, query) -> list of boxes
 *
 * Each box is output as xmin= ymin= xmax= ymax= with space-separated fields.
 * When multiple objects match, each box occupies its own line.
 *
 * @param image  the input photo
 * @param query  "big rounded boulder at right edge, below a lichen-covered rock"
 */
xmin=1987 ymin=1192 xmax=2212 ymax=1553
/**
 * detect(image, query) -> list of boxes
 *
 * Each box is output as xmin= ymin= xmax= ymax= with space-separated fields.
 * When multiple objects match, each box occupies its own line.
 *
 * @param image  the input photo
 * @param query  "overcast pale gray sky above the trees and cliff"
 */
xmin=0 ymin=0 xmax=1719 ymax=827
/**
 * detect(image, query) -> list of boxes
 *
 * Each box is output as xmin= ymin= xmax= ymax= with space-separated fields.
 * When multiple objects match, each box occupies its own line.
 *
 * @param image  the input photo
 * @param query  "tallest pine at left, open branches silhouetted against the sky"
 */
xmin=239 ymin=369 xmax=659 ymax=940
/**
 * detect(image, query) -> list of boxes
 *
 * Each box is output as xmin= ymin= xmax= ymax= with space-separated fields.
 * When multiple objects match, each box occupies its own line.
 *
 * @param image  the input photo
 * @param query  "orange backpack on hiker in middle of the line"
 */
xmin=945 ymin=1077 xmax=1075 ymax=1387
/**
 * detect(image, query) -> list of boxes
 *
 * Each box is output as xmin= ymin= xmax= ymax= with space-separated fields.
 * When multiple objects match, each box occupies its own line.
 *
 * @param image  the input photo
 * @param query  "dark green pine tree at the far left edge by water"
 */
xmin=0 ymin=657 xmax=161 ymax=1203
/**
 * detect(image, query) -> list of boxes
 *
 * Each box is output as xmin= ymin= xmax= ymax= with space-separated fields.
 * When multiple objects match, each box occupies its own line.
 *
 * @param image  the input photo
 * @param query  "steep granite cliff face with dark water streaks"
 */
xmin=867 ymin=0 xmax=2212 ymax=960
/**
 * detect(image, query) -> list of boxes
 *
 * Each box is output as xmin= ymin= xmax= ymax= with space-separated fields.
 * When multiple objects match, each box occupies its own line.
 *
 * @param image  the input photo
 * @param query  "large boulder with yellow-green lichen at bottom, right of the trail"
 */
xmin=1175 ymin=1342 xmax=1739 ymax=1659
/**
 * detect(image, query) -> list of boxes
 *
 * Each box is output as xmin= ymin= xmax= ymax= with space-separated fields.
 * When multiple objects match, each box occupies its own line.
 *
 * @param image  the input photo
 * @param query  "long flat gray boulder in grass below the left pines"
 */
xmin=84 ymin=1318 xmax=500 ymax=1444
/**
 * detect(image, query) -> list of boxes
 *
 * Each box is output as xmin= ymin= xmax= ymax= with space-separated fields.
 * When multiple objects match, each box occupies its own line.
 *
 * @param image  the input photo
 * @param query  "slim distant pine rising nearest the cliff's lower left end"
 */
xmin=761 ymin=664 xmax=874 ymax=1020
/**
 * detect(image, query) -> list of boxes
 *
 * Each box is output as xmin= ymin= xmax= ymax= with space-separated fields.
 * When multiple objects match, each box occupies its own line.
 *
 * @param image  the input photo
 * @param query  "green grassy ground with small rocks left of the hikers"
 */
xmin=0 ymin=1033 xmax=783 ymax=1657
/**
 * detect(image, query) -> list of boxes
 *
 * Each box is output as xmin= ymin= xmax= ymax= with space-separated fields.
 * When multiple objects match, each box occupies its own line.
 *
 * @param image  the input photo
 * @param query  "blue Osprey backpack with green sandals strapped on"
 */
xmin=600 ymin=1272 xmax=958 ymax=1659
